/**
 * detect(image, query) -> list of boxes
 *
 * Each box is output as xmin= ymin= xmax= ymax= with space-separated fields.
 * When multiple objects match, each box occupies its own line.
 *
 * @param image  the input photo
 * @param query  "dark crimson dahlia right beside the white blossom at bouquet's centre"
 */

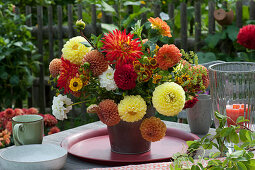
xmin=114 ymin=64 xmax=137 ymax=90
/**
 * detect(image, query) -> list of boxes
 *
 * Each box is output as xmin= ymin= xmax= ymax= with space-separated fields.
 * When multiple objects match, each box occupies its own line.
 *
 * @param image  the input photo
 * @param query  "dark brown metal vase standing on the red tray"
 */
xmin=107 ymin=106 xmax=155 ymax=154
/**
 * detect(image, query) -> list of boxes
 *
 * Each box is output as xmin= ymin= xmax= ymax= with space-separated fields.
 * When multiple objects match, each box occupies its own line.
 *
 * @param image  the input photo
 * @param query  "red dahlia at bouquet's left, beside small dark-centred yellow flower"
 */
xmin=57 ymin=57 xmax=79 ymax=94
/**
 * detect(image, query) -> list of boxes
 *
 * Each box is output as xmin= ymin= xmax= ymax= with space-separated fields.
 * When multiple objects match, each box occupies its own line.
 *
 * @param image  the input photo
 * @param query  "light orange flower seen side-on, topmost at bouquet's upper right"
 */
xmin=148 ymin=17 xmax=172 ymax=37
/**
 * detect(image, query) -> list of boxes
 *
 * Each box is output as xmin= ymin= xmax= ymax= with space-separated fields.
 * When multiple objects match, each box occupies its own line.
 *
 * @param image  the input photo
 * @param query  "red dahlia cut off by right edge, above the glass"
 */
xmin=237 ymin=24 xmax=255 ymax=49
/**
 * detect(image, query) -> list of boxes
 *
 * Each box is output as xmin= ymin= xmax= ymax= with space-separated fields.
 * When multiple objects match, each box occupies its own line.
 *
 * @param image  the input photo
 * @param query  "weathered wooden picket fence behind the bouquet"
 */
xmin=20 ymin=0 xmax=255 ymax=113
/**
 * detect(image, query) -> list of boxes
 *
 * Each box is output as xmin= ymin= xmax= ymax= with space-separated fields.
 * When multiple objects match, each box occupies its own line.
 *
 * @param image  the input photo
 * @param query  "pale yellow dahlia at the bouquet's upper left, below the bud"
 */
xmin=62 ymin=36 xmax=91 ymax=65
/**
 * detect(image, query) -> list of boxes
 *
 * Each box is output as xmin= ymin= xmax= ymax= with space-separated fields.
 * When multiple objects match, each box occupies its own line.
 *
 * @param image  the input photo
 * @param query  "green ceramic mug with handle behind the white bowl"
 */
xmin=12 ymin=115 xmax=44 ymax=145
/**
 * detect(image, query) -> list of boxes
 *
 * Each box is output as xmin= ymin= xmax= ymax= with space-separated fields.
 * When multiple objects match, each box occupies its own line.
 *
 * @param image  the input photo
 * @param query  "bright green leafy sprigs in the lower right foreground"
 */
xmin=170 ymin=112 xmax=255 ymax=170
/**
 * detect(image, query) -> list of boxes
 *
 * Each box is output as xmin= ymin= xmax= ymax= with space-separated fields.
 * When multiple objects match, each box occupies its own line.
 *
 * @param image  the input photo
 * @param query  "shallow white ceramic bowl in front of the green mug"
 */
xmin=0 ymin=144 xmax=67 ymax=170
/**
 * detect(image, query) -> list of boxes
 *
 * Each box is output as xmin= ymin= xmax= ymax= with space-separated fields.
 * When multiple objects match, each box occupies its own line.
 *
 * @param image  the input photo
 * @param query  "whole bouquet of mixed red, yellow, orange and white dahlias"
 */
xmin=49 ymin=18 xmax=209 ymax=141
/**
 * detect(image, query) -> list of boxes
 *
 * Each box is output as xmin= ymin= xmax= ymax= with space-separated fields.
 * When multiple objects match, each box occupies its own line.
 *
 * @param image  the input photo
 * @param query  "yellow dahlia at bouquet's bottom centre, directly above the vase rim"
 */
xmin=118 ymin=95 xmax=147 ymax=122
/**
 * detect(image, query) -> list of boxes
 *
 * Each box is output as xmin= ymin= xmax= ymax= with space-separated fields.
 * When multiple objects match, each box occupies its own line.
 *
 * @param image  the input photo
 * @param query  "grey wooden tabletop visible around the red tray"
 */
xmin=0 ymin=121 xmax=215 ymax=170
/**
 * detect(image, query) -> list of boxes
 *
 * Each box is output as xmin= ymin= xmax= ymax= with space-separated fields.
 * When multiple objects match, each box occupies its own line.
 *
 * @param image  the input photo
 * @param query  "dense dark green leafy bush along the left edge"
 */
xmin=0 ymin=3 xmax=38 ymax=108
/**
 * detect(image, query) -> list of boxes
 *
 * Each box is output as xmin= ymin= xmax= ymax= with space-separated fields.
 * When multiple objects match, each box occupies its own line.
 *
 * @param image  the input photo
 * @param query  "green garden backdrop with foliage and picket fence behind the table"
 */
xmin=0 ymin=0 xmax=255 ymax=129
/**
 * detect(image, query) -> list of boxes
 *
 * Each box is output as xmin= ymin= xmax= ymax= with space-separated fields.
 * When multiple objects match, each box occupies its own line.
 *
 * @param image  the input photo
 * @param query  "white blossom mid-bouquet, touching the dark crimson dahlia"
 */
xmin=99 ymin=68 xmax=117 ymax=91
